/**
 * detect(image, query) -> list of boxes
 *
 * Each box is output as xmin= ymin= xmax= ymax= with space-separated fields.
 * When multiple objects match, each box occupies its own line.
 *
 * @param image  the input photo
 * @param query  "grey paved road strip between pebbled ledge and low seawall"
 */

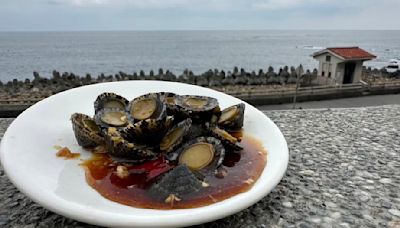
xmin=258 ymin=94 xmax=400 ymax=110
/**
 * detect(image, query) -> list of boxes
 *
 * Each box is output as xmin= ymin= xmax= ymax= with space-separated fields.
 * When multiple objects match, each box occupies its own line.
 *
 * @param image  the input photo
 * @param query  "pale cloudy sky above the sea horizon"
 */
xmin=0 ymin=0 xmax=400 ymax=31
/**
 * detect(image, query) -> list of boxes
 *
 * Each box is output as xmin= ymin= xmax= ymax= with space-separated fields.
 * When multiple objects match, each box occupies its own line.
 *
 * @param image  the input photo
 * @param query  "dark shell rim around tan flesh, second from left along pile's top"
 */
xmin=126 ymin=93 xmax=167 ymax=123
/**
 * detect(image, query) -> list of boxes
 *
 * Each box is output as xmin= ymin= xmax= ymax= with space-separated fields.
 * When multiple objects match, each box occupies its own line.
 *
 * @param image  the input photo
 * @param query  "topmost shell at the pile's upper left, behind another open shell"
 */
xmin=94 ymin=93 xmax=129 ymax=114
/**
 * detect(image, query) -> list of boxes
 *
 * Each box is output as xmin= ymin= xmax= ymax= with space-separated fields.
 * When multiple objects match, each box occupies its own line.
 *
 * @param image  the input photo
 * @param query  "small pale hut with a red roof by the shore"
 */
xmin=312 ymin=47 xmax=376 ymax=84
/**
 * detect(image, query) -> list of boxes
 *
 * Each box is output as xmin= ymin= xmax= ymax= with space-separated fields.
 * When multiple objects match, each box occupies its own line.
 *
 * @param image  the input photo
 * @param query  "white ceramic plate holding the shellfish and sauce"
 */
xmin=0 ymin=81 xmax=289 ymax=227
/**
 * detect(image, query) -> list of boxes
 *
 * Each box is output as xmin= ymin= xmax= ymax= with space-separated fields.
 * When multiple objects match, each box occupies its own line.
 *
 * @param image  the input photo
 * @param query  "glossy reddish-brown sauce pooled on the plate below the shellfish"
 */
xmin=82 ymin=136 xmax=267 ymax=209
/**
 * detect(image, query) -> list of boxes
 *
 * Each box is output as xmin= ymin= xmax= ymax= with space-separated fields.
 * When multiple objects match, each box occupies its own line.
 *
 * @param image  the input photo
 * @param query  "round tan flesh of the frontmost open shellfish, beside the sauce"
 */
xmin=179 ymin=143 xmax=215 ymax=170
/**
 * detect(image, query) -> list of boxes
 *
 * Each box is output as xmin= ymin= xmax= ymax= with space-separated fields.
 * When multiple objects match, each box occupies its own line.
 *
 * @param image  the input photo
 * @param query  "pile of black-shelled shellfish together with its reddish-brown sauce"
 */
xmin=71 ymin=92 xmax=267 ymax=210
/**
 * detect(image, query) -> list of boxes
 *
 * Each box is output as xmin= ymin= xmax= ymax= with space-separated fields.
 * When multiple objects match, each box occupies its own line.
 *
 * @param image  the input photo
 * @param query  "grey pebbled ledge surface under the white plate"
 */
xmin=0 ymin=105 xmax=400 ymax=228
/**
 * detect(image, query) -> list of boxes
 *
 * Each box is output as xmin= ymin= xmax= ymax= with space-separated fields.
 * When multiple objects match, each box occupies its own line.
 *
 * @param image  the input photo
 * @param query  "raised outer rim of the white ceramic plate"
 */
xmin=0 ymin=80 xmax=289 ymax=227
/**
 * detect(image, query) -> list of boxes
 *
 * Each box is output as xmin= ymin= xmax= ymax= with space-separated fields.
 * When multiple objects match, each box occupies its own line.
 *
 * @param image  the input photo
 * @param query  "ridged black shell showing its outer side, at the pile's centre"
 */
xmin=124 ymin=116 xmax=173 ymax=147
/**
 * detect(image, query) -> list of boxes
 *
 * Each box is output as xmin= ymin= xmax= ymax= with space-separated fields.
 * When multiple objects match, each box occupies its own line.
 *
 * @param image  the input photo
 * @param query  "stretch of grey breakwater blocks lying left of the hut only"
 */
xmin=0 ymin=67 xmax=317 ymax=102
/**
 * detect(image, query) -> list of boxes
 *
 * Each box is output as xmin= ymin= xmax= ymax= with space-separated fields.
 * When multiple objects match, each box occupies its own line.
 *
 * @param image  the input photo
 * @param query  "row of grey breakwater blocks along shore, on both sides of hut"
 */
xmin=0 ymin=66 xmax=400 ymax=104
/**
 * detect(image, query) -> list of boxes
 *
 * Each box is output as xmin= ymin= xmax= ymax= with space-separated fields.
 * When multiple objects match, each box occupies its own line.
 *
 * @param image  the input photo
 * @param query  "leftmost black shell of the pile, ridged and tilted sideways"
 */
xmin=71 ymin=113 xmax=104 ymax=148
